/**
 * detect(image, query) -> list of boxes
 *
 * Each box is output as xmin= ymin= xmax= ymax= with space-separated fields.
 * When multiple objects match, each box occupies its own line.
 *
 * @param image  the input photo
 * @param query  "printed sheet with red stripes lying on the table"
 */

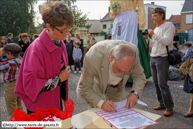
xmin=96 ymin=107 xmax=157 ymax=128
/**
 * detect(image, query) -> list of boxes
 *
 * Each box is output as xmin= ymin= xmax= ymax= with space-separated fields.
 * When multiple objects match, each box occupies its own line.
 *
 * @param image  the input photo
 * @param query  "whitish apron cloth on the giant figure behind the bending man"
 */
xmin=112 ymin=10 xmax=138 ymax=46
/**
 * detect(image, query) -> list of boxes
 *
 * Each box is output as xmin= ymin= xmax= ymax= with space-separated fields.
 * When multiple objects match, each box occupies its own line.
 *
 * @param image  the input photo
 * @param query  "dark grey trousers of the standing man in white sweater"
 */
xmin=150 ymin=57 xmax=174 ymax=110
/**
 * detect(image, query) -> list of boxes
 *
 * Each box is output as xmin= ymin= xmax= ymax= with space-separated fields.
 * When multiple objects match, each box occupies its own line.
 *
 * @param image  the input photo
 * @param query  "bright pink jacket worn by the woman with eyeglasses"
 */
xmin=15 ymin=29 xmax=68 ymax=112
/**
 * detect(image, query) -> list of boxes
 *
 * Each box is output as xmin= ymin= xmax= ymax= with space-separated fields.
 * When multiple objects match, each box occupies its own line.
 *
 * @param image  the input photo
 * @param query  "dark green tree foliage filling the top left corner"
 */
xmin=0 ymin=0 xmax=37 ymax=35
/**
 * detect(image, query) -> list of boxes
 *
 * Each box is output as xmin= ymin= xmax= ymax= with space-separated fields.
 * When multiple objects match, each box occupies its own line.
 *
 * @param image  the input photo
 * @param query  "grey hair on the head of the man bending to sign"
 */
xmin=112 ymin=44 xmax=136 ymax=61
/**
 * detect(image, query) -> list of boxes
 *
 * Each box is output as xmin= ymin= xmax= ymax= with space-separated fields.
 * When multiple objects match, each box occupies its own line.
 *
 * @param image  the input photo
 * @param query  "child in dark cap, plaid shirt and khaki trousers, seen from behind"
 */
xmin=0 ymin=43 xmax=23 ymax=117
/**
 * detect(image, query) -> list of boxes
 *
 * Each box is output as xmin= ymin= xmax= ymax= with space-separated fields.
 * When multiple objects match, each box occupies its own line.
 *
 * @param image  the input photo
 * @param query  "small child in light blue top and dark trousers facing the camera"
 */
xmin=72 ymin=43 xmax=82 ymax=73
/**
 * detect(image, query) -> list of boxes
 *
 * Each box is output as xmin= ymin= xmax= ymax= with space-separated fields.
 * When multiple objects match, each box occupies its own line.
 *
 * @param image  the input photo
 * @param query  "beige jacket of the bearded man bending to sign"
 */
xmin=76 ymin=40 xmax=146 ymax=107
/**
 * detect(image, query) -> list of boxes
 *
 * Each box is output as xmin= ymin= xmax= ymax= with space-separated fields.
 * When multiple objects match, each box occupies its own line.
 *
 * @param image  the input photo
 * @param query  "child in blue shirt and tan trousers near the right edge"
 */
xmin=180 ymin=43 xmax=192 ymax=75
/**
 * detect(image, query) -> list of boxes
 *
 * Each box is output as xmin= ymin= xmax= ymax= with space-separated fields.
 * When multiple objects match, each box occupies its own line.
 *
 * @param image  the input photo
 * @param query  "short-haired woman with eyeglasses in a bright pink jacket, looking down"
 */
xmin=15 ymin=1 xmax=73 ymax=114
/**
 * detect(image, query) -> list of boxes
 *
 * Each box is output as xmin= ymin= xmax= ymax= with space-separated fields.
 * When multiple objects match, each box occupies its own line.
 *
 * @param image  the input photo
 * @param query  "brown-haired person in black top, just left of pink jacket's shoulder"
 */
xmin=18 ymin=33 xmax=30 ymax=57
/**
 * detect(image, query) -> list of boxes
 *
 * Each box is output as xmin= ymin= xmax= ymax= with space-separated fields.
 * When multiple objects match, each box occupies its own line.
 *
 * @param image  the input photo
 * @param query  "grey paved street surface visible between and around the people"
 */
xmin=0 ymin=45 xmax=193 ymax=129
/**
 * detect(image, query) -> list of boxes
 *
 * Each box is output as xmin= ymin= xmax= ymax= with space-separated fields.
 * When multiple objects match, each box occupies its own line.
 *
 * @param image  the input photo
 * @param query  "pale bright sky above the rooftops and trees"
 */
xmin=35 ymin=0 xmax=185 ymax=26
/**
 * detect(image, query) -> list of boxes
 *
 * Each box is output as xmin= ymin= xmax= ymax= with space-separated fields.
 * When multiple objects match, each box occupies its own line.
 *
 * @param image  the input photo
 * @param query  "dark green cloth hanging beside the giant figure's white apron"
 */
xmin=128 ymin=29 xmax=151 ymax=82
